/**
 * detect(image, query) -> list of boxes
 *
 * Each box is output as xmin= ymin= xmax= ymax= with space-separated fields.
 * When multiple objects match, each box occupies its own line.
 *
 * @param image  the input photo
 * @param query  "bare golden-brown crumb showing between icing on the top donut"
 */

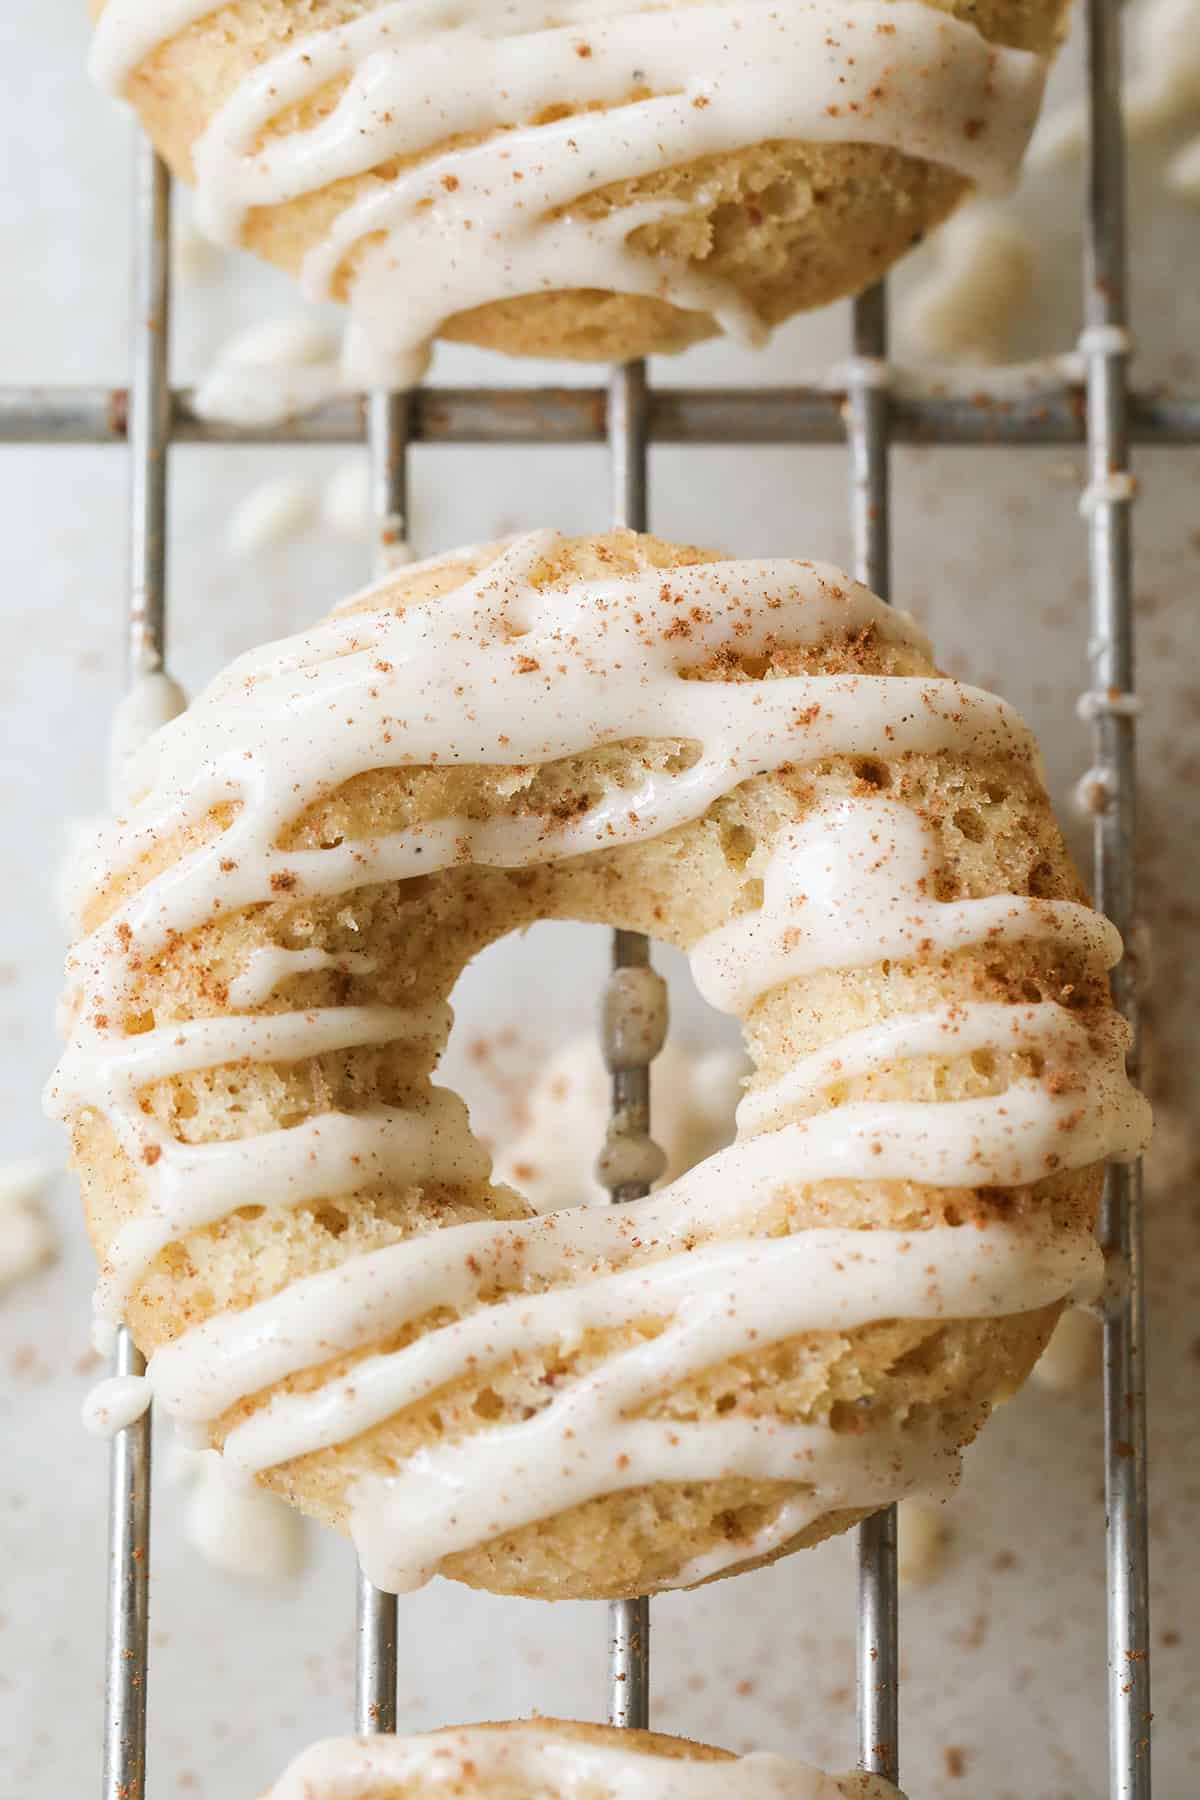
xmin=92 ymin=0 xmax=1069 ymax=358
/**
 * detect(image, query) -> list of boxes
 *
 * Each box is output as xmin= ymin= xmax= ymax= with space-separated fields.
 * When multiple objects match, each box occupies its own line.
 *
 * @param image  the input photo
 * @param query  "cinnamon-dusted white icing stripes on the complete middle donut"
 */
xmin=49 ymin=533 xmax=1146 ymax=1588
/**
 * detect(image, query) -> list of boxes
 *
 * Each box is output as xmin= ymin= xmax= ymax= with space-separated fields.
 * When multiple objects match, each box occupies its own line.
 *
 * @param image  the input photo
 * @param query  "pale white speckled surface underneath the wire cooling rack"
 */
xmin=0 ymin=0 xmax=1200 ymax=1800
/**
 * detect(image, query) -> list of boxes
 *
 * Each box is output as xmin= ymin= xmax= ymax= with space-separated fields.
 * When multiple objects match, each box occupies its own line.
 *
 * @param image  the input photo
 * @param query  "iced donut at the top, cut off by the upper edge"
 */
xmin=92 ymin=0 xmax=1069 ymax=374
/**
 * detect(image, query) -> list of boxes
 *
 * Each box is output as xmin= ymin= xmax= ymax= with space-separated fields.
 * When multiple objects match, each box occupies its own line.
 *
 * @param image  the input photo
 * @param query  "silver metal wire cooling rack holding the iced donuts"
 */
xmin=0 ymin=0 xmax=1180 ymax=1800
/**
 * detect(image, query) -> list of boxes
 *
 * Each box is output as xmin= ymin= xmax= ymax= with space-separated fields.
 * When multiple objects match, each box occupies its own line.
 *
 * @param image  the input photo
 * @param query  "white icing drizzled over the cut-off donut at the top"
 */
xmin=92 ymin=0 xmax=1045 ymax=385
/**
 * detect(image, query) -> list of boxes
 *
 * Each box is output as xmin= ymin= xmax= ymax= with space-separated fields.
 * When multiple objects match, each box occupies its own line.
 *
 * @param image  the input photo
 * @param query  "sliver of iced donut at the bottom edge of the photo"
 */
xmin=263 ymin=1719 xmax=903 ymax=1800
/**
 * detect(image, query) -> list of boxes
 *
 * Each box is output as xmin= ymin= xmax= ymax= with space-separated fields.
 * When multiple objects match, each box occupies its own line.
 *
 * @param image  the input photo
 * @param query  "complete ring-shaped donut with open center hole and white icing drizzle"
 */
xmin=50 ymin=531 xmax=1146 ymax=1598
